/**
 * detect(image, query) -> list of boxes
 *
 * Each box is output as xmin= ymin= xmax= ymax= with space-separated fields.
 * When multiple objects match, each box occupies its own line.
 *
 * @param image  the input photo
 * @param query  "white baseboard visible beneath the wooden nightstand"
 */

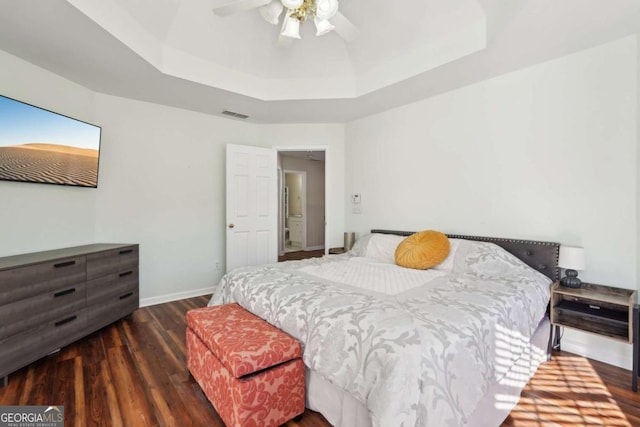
xmin=560 ymin=328 xmax=633 ymax=370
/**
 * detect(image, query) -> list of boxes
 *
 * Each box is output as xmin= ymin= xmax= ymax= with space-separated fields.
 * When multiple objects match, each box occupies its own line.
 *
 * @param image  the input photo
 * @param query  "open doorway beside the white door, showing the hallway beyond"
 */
xmin=278 ymin=150 xmax=326 ymax=255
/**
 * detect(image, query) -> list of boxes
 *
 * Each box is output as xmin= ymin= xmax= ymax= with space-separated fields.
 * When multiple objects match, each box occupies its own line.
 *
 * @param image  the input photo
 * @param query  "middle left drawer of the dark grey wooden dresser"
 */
xmin=0 ymin=283 xmax=87 ymax=340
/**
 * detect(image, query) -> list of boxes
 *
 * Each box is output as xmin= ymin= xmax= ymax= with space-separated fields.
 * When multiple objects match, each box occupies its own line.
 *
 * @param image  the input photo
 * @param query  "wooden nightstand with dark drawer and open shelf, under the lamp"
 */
xmin=551 ymin=282 xmax=640 ymax=391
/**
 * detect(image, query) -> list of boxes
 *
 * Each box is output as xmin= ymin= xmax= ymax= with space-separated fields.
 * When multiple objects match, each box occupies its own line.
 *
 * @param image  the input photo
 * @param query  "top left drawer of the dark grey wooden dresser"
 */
xmin=0 ymin=256 xmax=86 ymax=305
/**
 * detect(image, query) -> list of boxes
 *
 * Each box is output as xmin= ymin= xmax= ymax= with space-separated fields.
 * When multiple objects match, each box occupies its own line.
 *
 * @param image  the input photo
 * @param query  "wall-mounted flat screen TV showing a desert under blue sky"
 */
xmin=0 ymin=95 xmax=101 ymax=188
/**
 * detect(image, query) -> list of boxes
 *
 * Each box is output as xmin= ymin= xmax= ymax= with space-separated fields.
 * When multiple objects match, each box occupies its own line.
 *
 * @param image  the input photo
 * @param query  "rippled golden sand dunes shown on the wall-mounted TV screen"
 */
xmin=0 ymin=144 xmax=98 ymax=187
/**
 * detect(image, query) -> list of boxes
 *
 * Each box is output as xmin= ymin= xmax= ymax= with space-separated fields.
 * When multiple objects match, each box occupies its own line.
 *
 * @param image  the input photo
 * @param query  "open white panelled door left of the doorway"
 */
xmin=227 ymin=144 xmax=278 ymax=271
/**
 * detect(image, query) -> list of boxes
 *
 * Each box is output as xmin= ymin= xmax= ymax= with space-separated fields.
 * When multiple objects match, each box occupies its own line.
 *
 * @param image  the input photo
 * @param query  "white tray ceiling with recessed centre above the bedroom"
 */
xmin=0 ymin=0 xmax=640 ymax=122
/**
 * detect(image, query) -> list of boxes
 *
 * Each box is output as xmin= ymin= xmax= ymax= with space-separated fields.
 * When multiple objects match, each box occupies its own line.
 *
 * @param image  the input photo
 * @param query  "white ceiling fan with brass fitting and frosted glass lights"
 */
xmin=213 ymin=0 xmax=359 ymax=42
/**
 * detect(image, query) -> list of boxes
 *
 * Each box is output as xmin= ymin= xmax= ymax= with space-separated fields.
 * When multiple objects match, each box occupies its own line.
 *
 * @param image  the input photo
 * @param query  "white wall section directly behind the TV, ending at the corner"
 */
xmin=0 ymin=51 xmax=98 ymax=256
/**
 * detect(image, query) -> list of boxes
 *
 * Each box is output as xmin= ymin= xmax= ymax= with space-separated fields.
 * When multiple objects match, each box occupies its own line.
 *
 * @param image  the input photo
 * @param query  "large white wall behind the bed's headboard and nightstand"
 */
xmin=345 ymin=37 xmax=638 ymax=367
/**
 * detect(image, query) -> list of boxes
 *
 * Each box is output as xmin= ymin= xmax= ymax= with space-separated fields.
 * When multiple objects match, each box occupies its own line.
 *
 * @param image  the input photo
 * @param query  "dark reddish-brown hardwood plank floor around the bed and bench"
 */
xmin=0 ymin=297 xmax=640 ymax=427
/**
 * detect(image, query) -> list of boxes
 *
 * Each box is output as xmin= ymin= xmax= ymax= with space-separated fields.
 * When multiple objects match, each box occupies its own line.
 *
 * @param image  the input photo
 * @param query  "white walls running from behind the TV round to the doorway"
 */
xmin=0 ymin=52 xmax=344 ymax=304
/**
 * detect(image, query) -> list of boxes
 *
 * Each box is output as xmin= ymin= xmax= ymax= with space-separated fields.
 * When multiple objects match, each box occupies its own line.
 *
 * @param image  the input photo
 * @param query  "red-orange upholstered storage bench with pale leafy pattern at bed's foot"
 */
xmin=187 ymin=304 xmax=305 ymax=427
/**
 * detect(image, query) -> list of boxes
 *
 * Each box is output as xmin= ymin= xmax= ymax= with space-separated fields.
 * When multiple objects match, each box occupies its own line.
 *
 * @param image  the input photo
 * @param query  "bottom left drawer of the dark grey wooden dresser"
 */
xmin=0 ymin=309 xmax=87 ymax=377
